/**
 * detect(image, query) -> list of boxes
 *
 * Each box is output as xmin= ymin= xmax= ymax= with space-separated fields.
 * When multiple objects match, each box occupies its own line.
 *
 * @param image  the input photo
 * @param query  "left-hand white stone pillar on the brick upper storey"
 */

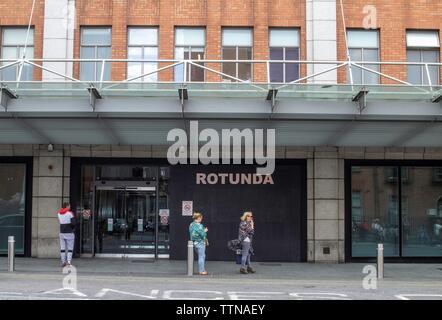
xmin=43 ymin=0 xmax=75 ymax=81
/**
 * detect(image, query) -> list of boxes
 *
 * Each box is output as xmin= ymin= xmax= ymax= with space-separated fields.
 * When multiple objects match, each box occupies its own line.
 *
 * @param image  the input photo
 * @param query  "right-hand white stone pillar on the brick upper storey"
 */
xmin=306 ymin=0 xmax=337 ymax=83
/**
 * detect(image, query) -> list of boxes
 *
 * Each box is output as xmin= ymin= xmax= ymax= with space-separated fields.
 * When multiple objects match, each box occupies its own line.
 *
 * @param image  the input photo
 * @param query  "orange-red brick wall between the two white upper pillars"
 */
xmin=74 ymin=0 xmax=305 ymax=81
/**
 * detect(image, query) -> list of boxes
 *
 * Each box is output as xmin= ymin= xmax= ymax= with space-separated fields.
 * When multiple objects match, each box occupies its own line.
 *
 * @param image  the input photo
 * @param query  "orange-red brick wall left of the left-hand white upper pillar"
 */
xmin=0 ymin=0 xmax=44 ymax=80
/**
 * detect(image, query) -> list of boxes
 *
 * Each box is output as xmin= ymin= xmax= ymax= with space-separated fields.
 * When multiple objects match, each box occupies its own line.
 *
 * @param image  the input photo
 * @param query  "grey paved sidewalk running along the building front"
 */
xmin=0 ymin=257 xmax=442 ymax=281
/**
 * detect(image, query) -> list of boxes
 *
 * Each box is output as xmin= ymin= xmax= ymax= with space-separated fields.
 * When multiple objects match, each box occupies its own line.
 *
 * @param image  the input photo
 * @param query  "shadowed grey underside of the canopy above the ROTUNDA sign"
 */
xmin=0 ymin=118 xmax=442 ymax=147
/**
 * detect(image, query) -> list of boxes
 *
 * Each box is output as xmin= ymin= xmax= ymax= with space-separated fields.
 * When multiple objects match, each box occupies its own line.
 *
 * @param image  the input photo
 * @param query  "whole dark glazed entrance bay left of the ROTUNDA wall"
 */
xmin=76 ymin=164 xmax=170 ymax=258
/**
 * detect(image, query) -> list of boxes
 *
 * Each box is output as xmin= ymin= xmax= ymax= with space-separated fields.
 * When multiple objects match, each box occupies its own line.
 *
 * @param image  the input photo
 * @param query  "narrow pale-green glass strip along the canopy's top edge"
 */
xmin=0 ymin=81 xmax=442 ymax=103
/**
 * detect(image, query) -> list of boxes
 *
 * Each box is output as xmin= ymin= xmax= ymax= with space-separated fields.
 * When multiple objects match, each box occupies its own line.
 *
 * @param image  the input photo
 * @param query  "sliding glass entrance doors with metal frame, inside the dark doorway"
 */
xmin=95 ymin=186 xmax=158 ymax=257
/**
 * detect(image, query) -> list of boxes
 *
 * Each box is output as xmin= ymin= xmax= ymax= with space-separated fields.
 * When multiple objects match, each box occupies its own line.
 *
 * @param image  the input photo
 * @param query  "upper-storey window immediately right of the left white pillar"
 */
xmin=80 ymin=28 xmax=112 ymax=81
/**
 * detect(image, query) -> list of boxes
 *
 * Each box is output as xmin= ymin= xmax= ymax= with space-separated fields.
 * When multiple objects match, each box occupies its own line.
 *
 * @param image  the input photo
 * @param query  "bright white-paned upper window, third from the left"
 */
xmin=127 ymin=28 xmax=158 ymax=82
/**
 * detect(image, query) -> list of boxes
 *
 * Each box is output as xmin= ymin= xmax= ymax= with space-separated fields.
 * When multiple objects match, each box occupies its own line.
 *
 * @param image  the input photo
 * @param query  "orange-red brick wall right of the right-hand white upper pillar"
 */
xmin=337 ymin=0 xmax=442 ymax=83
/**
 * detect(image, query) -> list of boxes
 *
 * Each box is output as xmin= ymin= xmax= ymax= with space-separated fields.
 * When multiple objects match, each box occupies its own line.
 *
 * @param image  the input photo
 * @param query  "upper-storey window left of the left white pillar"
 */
xmin=0 ymin=28 xmax=34 ymax=81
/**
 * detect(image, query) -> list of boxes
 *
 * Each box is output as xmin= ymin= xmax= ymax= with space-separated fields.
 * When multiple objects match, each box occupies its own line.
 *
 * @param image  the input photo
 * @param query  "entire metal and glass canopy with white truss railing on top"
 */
xmin=0 ymin=59 xmax=442 ymax=146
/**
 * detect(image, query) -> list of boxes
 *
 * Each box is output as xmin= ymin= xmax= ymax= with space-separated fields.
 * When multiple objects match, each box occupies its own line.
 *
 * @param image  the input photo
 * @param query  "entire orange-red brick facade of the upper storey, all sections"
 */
xmin=0 ymin=0 xmax=442 ymax=83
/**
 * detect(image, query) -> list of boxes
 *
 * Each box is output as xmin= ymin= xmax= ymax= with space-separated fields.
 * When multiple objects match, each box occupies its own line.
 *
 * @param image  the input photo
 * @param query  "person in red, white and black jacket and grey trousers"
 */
xmin=58 ymin=202 xmax=75 ymax=267
